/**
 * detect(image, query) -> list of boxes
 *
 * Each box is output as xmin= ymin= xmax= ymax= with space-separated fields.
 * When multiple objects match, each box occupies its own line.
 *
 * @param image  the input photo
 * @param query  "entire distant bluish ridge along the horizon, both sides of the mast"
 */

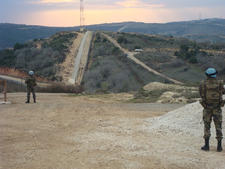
xmin=0 ymin=18 xmax=225 ymax=49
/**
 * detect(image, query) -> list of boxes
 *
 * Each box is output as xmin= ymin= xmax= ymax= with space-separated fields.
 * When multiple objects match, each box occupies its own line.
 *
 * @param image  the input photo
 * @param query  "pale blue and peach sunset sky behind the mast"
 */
xmin=0 ymin=0 xmax=225 ymax=27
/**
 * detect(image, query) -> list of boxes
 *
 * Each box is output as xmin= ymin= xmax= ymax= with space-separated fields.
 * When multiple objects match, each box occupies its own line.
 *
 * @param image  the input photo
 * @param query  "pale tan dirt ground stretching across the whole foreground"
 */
xmin=0 ymin=93 xmax=225 ymax=169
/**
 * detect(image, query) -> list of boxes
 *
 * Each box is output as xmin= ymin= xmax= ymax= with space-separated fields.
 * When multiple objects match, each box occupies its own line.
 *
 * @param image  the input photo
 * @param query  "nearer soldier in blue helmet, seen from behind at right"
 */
xmin=199 ymin=68 xmax=225 ymax=152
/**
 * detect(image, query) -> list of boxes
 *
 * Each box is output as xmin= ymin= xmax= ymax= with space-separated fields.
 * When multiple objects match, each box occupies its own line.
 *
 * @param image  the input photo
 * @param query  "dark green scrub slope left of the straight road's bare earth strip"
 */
xmin=0 ymin=32 xmax=77 ymax=81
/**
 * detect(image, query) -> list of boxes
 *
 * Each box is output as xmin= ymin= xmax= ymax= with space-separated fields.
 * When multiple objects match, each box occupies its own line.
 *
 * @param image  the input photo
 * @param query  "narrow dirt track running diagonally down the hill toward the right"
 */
xmin=102 ymin=33 xmax=183 ymax=84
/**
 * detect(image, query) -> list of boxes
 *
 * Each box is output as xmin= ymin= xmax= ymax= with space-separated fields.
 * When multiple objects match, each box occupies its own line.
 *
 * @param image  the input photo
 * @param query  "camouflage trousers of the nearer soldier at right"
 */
xmin=203 ymin=107 xmax=223 ymax=140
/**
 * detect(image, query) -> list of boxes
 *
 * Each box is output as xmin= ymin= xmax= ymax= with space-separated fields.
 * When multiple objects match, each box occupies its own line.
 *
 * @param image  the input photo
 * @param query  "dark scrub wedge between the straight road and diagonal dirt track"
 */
xmin=83 ymin=33 xmax=163 ymax=93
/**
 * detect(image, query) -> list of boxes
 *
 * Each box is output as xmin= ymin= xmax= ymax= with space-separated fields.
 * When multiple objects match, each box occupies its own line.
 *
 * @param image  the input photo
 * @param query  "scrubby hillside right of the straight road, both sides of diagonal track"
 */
xmin=83 ymin=32 xmax=225 ymax=92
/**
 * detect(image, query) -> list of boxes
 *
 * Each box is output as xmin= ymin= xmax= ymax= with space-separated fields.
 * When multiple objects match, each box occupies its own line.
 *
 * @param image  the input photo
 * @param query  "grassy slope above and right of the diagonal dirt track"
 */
xmin=108 ymin=32 xmax=225 ymax=83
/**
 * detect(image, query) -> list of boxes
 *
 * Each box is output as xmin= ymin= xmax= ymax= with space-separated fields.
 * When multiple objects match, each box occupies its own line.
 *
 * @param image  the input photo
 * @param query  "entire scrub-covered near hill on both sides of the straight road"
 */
xmin=0 ymin=31 xmax=225 ymax=95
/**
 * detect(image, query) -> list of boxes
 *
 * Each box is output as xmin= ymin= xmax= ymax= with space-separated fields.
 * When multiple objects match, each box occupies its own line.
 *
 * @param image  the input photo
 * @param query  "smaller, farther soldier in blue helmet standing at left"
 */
xmin=25 ymin=71 xmax=37 ymax=103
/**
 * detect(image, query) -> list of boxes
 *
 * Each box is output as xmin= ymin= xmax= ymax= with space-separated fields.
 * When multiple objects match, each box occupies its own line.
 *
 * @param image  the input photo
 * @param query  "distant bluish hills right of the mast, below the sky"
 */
xmin=87 ymin=19 xmax=225 ymax=43
